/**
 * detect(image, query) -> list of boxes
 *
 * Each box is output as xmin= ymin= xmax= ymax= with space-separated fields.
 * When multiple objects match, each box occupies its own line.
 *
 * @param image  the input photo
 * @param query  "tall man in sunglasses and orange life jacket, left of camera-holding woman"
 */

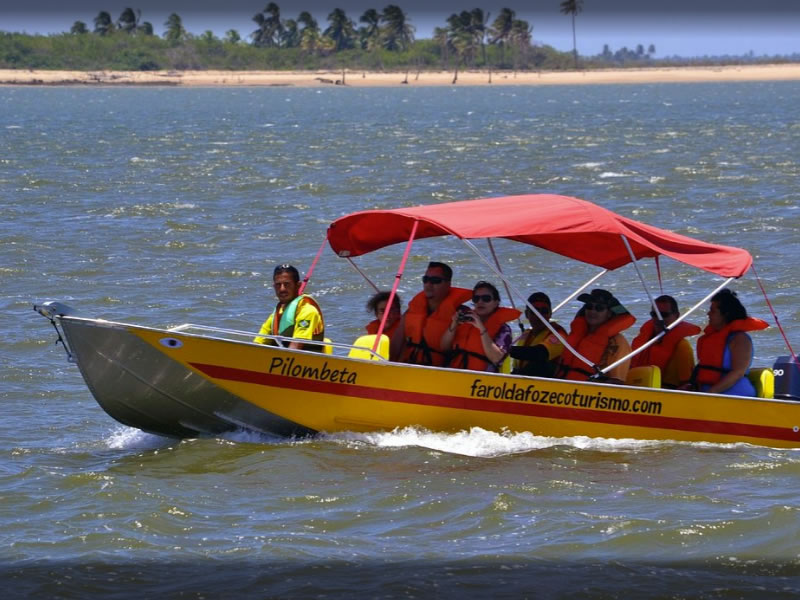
xmin=390 ymin=262 xmax=472 ymax=367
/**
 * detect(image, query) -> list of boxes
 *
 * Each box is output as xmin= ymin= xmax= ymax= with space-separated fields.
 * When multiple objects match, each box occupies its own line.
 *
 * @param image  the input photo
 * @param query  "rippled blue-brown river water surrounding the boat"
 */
xmin=0 ymin=83 xmax=800 ymax=598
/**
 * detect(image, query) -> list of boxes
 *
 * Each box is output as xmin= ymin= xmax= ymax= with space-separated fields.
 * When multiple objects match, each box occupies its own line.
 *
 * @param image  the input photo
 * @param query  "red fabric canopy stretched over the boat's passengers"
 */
xmin=328 ymin=194 xmax=753 ymax=277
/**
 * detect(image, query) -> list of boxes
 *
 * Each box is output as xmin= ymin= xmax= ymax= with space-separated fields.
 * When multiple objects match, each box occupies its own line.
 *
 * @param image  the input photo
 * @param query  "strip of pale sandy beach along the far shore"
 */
xmin=0 ymin=63 xmax=800 ymax=87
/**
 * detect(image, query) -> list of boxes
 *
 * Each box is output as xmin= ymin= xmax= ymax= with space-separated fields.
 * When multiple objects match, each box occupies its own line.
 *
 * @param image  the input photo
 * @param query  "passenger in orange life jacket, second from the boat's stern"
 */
xmin=631 ymin=294 xmax=701 ymax=390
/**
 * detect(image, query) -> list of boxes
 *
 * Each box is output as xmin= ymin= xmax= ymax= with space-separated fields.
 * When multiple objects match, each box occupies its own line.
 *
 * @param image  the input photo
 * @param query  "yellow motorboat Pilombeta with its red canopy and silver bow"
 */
xmin=34 ymin=194 xmax=800 ymax=447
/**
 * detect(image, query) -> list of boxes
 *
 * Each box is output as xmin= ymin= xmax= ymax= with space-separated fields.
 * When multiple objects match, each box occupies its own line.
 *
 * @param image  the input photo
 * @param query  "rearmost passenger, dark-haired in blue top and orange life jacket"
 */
xmin=693 ymin=289 xmax=769 ymax=396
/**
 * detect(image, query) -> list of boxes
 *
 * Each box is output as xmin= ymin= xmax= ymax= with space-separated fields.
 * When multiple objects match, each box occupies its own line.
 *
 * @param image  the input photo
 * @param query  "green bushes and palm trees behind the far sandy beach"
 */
xmin=0 ymin=0 xmax=796 ymax=72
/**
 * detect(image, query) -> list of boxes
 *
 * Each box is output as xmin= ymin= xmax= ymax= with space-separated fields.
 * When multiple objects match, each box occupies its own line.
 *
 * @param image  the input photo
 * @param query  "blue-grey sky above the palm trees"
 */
xmin=0 ymin=0 xmax=800 ymax=58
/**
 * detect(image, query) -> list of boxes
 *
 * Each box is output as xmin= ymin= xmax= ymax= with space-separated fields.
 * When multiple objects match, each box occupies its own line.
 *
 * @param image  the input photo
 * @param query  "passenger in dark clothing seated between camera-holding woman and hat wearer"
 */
xmin=511 ymin=292 xmax=567 ymax=377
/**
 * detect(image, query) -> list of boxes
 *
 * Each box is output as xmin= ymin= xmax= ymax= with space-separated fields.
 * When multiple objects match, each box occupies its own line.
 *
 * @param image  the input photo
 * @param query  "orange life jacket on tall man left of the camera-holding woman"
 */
xmin=400 ymin=287 xmax=472 ymax=367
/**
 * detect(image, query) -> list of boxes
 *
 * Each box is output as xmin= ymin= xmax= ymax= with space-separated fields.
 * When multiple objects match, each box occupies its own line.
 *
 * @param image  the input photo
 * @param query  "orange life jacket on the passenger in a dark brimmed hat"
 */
xmin=556 ymin=313 xmax=636 ymax=381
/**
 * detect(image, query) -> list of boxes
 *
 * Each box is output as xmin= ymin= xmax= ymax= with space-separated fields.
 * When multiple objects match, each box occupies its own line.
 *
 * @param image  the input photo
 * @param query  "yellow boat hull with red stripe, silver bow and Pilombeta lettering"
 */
xmin=63 ymin=318 xmax=800 ymax=447
